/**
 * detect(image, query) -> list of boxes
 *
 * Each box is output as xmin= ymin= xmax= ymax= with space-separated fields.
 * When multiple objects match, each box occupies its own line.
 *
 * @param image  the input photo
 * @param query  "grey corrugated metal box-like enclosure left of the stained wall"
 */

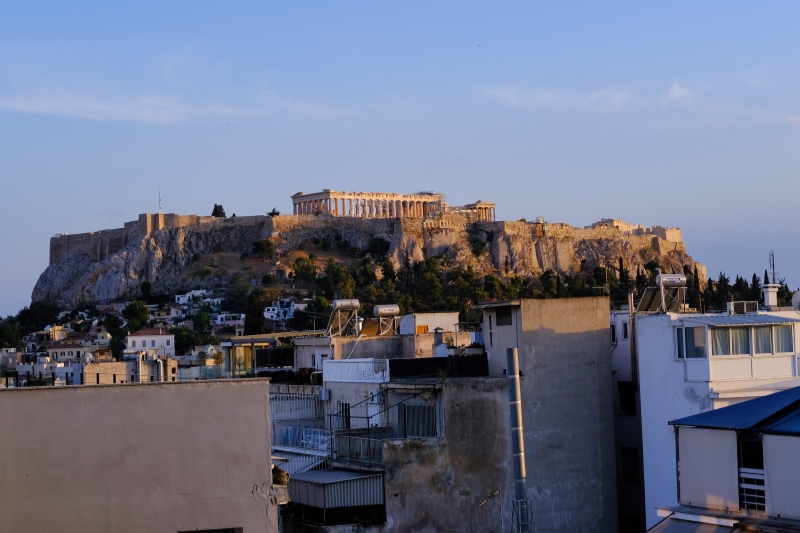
xmin=289 ymin=469 xmax=383 ymax=509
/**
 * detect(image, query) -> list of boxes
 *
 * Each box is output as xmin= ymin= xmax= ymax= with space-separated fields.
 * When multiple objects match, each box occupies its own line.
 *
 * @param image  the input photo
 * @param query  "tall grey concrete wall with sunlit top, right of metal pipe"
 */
xmin=483 ymin=297 xmax=617 ymax=533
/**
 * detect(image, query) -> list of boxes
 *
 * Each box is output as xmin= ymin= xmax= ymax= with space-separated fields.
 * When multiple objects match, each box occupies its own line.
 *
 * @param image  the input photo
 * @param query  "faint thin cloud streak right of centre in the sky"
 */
xmin=485 ymin=86 xmax=635 ymax=113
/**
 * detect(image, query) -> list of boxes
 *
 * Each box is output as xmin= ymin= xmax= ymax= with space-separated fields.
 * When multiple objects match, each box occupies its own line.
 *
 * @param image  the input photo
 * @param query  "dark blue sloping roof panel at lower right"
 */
xmin=670 ymin=387 xmax=800 ymax=429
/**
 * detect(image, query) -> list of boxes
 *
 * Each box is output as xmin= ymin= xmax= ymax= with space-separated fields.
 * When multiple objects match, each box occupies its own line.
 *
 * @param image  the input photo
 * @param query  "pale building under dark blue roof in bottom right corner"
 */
xmin=651 ymin=387 xmax=800 ymax=533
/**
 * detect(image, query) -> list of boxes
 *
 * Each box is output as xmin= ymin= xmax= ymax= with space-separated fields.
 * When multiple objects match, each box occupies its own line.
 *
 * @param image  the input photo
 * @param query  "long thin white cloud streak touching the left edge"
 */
xmin=0 ymin=94 xmax=247 ymax=126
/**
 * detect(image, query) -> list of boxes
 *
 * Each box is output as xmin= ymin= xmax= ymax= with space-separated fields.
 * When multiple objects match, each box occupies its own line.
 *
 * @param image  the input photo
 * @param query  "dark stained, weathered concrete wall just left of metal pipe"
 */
xmin=383 ymin=378 xmax=513 ymax=533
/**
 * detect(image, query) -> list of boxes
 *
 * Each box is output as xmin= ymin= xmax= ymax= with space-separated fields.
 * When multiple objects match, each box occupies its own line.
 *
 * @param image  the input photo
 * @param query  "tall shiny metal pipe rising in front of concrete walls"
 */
xmin=506 ymin=348 xmax=530 ymax=533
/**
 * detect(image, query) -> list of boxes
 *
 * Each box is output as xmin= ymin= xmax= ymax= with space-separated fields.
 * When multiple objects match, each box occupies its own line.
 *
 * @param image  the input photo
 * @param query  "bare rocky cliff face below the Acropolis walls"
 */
xmin=31 ymin=215 xmax=705 ymax=307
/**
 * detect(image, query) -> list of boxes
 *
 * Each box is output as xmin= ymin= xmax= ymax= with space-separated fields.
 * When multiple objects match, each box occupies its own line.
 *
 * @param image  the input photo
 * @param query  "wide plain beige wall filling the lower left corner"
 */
xmin=0 ymin=379 xmax=277 ymax=533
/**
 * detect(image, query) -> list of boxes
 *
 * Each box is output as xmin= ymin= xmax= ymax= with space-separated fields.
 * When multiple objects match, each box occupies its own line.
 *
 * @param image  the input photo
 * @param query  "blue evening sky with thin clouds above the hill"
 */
xmin=0 ymin=0 xmax=800 ymax=316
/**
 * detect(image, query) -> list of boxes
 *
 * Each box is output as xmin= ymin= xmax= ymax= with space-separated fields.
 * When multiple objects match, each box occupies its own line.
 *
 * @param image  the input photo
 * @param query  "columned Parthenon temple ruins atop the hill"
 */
xmin=292 ymin=189 xmax=496 ymax=221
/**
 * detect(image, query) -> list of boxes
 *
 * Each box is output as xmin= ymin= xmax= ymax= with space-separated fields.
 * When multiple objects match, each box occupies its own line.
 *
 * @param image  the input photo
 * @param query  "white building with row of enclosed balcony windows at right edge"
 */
xmin=634 ymin=302 xmax=800 ymax=527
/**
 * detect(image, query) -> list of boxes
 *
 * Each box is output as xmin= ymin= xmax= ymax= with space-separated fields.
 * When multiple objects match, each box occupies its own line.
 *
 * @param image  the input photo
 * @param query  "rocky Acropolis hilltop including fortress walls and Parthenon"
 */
xmin=32 ymin=190 xmax=706 ymax=306
